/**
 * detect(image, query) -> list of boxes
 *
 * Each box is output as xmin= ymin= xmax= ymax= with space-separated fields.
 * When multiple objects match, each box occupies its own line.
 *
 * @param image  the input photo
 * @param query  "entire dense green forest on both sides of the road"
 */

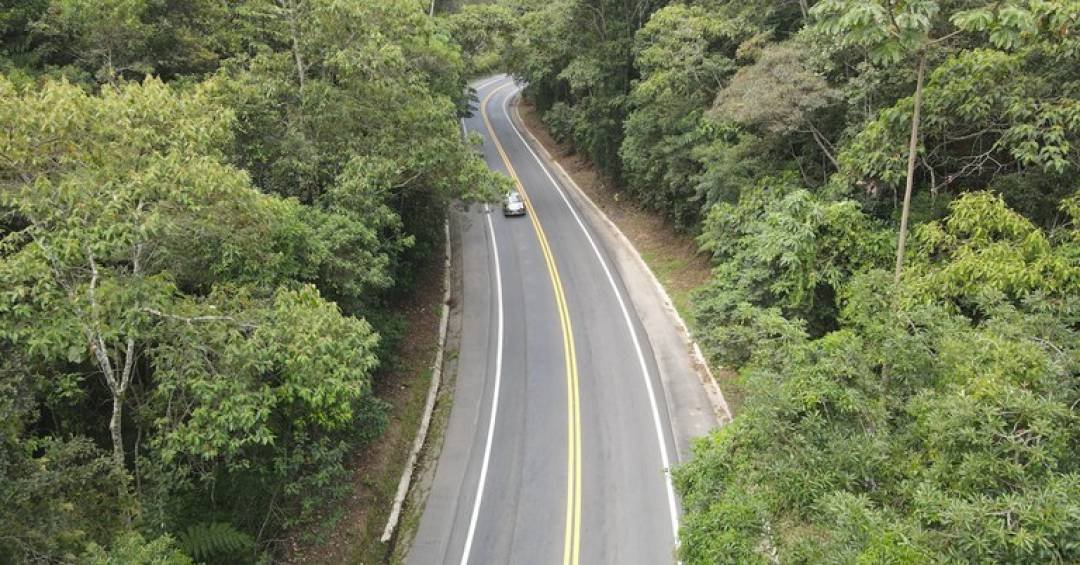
xmin=0 ymin=0 xmax=1080 ymax=564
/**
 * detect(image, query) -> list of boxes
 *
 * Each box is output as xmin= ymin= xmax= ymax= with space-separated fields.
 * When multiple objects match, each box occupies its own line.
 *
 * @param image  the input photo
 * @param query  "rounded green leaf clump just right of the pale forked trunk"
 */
xmin=152 ymin=287 xmax=378 ymax=467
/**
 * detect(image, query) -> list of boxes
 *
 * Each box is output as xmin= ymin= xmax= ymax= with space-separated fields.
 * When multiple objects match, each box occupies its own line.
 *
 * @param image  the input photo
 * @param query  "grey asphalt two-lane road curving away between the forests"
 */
xmin=408 ymin=77 xmax=717 ymax=565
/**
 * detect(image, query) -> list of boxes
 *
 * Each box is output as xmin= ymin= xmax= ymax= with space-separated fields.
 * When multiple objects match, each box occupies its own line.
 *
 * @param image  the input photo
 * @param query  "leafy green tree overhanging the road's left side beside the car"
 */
xmin=209 ymin=1 xmax=495 ymax=207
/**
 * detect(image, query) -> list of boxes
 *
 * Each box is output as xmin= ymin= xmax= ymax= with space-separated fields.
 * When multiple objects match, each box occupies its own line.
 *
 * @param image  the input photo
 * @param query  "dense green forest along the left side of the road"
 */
xmin=0 ymin=0 xmax=501 ymax=563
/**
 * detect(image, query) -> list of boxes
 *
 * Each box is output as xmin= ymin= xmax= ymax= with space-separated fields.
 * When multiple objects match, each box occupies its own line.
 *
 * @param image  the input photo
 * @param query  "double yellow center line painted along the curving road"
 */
xmin=480 ymin=82 xmax=581 ymax=565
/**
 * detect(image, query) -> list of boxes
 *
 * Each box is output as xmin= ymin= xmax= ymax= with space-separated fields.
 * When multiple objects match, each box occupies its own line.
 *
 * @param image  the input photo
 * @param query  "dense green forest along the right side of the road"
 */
xmin=475 ymin=0 xmax=1080 ymax=564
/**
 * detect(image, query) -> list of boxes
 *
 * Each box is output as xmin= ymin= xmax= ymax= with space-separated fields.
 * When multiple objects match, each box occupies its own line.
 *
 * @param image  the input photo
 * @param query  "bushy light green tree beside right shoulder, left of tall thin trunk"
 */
xmin=693 ymin=179 xmax=891 ymax=366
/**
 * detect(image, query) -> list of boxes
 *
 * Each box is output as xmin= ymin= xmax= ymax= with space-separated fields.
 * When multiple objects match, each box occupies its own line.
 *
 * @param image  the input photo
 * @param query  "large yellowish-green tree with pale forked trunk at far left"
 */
xmin=0 ymin=75 xmax=378 ymax=493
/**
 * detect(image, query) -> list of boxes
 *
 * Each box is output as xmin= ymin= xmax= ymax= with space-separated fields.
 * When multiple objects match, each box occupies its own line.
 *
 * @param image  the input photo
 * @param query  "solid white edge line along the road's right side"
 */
xmin=502 ymin=89 xmax=678 ymax=544
